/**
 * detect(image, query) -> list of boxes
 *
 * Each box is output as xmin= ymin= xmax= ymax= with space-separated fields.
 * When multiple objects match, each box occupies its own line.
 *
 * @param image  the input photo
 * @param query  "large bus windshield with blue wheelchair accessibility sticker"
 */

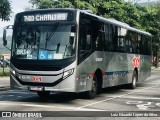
xmin=12 ymin=22 xmax=76 ymax=60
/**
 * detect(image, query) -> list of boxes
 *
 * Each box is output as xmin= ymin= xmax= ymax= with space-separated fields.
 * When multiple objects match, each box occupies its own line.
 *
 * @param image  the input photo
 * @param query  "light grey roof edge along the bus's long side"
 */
xmin=80 ymin=10 xmax=152 ymax=36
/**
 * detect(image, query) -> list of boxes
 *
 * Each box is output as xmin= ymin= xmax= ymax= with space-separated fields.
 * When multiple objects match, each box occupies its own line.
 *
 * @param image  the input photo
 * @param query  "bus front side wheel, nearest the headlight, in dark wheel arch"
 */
xmin=86 ymin=75 xmax=98 ymax=99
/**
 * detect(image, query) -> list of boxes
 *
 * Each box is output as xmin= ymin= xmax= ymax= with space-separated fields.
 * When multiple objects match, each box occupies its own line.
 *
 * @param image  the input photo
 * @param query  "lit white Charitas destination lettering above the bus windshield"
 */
xmin=23 ymin=13 xmax=68 ymax=22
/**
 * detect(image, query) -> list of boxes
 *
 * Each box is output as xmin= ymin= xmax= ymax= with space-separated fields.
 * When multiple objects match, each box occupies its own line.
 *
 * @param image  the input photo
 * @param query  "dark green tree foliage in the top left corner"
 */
xmin=0 ymin=0 xmax=11 ymax=21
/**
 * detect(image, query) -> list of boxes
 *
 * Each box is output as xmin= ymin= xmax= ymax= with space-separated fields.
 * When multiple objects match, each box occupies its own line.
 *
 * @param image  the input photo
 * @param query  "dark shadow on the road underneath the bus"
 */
xmin=0 ymin=86 xmax=139 ymax=104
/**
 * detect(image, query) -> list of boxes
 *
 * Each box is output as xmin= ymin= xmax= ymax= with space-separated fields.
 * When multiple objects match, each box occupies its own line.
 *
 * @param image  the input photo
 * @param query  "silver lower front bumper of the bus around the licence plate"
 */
xmin=10 ymin=74 xmax=76 ymax=92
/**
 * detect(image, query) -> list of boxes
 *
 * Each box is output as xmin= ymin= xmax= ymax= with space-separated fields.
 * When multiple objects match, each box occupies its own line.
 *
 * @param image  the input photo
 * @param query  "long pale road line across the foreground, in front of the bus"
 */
xmin=0 ymin=101 xmax=107 ymax=111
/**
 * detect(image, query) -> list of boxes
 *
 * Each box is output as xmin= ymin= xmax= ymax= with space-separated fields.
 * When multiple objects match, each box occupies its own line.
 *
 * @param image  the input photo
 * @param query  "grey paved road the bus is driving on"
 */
xmin=0 ymin=71 xmax=160 ymax=120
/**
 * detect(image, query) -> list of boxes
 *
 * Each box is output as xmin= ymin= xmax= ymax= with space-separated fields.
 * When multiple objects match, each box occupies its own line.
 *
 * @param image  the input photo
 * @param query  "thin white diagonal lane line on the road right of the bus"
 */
xmin=78 ymin=85 xmax=160 ymax=109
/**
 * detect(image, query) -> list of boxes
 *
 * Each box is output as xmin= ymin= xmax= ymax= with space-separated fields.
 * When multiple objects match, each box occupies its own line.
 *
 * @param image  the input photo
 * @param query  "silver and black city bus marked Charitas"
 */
xmin=3 ymin=8 xmax=152 ymax=99
